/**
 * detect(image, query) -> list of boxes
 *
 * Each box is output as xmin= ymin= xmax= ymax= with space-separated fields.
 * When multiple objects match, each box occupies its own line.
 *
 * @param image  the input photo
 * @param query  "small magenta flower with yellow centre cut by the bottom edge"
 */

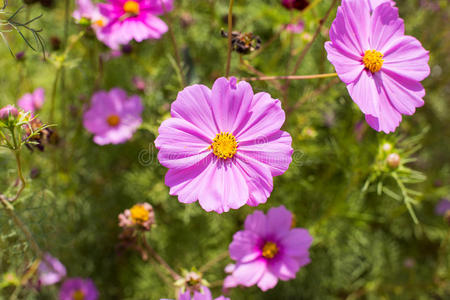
xmin=59 ymin=278 xmax=98 ymax=300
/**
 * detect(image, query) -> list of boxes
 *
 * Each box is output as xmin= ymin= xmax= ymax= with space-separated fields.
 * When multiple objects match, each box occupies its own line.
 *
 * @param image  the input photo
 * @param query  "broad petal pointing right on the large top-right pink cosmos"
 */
xmin=382 ymin=36 xmax=430 ymax=81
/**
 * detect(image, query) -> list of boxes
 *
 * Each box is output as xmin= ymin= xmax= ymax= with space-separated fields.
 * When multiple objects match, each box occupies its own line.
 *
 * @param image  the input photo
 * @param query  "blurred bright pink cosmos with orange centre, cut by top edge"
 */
xmin=99 ymin=0 xmax=173 ymax=49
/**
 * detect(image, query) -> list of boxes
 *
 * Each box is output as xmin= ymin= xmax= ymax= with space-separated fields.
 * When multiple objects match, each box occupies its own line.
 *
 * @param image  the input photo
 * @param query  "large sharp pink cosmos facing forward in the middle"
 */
xmin=155 ymin=77 xmax=293 ymax=213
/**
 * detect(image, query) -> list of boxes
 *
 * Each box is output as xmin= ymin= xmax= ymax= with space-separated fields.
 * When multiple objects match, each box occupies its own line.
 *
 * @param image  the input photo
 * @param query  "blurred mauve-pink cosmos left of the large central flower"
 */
xmin=83 ymin=88 xmax=144 ymax=145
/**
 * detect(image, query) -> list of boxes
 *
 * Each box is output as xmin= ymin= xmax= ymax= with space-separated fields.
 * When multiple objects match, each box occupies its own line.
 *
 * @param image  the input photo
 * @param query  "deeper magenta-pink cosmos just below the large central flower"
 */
xmin=224 ymin=206 xmax=312 ymax=291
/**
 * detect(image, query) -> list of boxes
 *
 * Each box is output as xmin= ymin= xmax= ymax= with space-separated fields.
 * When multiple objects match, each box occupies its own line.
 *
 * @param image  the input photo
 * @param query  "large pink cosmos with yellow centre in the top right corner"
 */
xmin=325 ymin=0 xmax=430 ymax=133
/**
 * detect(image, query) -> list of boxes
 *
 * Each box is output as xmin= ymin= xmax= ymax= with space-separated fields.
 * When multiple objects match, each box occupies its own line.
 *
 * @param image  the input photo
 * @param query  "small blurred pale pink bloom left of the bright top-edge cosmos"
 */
xmin=72 ymin=0 xmax=109 ymax=41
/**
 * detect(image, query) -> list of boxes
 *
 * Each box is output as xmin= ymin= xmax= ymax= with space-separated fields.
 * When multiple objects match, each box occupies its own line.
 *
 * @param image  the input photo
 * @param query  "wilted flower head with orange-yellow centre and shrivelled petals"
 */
xmin=119 ymin=202 xmax=155 ymax=230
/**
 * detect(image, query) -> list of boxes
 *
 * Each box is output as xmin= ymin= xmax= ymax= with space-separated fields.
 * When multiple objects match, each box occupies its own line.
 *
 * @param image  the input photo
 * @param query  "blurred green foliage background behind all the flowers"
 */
xmin=0 ymin=0 xmax=450 ymax=300
